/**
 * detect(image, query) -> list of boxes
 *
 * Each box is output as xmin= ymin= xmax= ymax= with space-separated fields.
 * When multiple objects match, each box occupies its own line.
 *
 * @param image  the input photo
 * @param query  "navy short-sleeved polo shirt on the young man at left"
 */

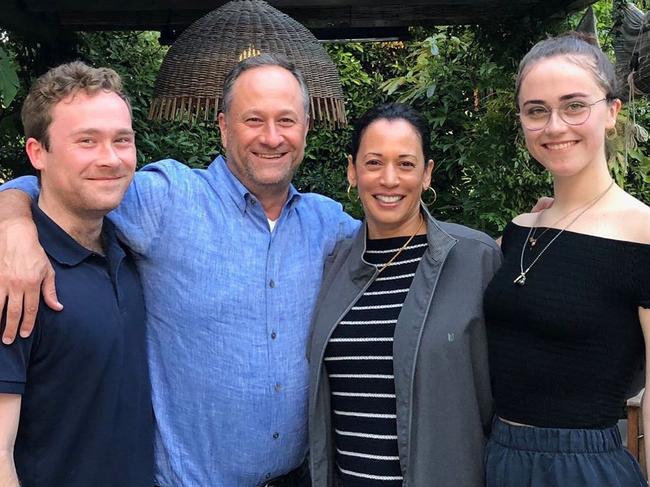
xmin=0 ymin=205 xmax=153 ymax=487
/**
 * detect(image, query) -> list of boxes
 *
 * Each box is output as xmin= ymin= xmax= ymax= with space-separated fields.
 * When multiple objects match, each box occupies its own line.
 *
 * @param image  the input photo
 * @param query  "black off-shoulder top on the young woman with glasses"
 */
xmin=484 ymin=223 xmax=650 ymax=428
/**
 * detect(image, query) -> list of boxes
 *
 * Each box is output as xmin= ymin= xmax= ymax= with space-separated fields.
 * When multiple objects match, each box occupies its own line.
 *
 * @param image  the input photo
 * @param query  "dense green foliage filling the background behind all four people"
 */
xmin=0 ymin=0 xmax=650 ymax=231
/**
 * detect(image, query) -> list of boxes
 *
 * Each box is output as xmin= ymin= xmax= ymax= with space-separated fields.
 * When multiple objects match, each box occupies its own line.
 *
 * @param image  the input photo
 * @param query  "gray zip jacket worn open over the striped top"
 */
xmin=307 ymin=210 xmax=501 ymax=487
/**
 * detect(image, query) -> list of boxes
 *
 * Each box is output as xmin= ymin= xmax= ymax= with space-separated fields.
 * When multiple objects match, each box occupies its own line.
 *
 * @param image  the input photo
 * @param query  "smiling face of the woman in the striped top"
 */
xmin=348 ymin=118 xmax=433 ymax=238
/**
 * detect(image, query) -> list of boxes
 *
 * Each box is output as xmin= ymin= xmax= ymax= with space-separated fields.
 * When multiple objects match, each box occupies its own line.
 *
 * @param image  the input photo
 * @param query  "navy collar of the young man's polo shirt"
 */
xmin=32 ymin=201 xmax=124 ymax=266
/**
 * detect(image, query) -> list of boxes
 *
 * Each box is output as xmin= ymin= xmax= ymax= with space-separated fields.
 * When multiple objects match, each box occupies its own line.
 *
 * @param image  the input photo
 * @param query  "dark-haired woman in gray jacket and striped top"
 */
xmin=309 ymin=103 xmax=500 ymax=487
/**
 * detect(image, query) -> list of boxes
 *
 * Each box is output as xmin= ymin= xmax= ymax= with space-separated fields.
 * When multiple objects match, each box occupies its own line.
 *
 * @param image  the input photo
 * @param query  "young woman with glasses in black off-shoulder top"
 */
xmin=485 ymin=33 xmax=650 ymax=487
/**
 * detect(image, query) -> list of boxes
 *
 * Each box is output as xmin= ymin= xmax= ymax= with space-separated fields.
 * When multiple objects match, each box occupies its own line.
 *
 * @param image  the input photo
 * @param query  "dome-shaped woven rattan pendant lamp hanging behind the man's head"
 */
xmin=149 ymin=0 xmax=346 ymax=127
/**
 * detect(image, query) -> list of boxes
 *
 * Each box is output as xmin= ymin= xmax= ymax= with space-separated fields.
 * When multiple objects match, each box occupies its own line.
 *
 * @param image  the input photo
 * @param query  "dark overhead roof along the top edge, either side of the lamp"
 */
xmin=0 ymin=0 xmax=595 ymax=42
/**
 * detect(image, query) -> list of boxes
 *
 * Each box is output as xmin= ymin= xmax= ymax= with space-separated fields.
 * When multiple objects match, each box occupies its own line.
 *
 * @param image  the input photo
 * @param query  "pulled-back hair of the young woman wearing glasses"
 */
xmin=515 ymin=32 xmax=619 ymax=103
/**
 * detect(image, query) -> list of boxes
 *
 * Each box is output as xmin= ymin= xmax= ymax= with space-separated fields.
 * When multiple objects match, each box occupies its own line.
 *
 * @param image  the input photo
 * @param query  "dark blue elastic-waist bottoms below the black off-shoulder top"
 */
xmin=485 ymin=419 xmax=648 ymax=487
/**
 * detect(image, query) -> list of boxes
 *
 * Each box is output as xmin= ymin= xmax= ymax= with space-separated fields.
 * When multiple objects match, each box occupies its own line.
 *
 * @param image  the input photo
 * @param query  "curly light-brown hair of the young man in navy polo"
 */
xmin=20 ymin=61 xmax=131 ymax=150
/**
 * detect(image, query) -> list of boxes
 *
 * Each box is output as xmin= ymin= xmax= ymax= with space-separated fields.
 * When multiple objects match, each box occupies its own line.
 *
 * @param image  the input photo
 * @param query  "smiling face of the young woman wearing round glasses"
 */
xmin=518 ymin=56 xmax=621 ymax=177
